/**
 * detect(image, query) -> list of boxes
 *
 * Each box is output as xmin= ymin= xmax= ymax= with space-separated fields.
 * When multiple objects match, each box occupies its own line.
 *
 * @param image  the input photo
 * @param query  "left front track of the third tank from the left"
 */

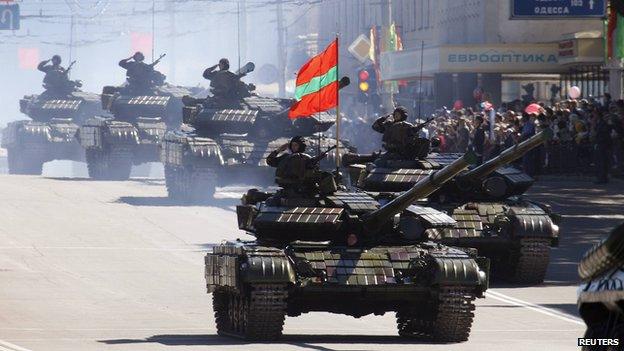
xmin=165 ymin=166 xmax=217 ymax=203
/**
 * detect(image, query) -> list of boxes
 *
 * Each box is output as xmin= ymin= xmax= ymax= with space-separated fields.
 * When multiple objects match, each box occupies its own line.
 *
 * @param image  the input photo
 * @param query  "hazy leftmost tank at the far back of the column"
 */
xmin=2 ymin=81 xmax=103 ymax=175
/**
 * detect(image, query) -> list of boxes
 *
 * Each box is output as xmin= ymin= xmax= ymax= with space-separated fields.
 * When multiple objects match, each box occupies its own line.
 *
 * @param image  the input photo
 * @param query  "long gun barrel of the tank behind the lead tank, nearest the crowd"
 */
xmin=461 ymin=129 xmax=552 ymax=184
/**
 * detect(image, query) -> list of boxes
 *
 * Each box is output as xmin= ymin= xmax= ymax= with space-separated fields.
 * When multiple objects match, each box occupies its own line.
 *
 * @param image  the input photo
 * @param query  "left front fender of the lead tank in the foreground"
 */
xmin=240 ymin=255 xmax=295 ymax=284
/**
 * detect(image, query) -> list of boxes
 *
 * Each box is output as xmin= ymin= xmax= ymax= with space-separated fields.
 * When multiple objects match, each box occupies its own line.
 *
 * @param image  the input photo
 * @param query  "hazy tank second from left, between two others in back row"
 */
xmin=79 ymin=63 xmax=193 ymax=180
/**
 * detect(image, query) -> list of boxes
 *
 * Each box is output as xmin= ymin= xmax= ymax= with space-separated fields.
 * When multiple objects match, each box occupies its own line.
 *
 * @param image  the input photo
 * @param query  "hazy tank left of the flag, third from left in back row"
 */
xmin=161 ymin=63 xmax=355 ymax=202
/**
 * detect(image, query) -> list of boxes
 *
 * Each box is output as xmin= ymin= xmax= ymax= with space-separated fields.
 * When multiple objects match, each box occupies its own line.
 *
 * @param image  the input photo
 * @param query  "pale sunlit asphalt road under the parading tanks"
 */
xmin=0 ymin=175 xmax=624 ymax=351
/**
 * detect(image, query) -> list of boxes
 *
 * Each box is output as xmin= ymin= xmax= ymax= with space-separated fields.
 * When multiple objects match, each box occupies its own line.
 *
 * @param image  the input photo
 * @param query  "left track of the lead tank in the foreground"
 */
xmin=212 ymin=284 xmax=288 ymax=341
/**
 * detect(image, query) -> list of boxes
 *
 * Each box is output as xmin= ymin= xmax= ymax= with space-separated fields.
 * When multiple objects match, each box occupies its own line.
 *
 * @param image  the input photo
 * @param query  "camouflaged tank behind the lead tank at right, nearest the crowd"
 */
xmin=344 ymin=131 xmax=559 ymax=284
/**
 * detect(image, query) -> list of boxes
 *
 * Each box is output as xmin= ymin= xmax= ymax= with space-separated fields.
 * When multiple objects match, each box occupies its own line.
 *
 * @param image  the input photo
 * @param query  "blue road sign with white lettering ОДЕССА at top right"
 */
xmin=511 ymin=0 xmax=607 ymax=19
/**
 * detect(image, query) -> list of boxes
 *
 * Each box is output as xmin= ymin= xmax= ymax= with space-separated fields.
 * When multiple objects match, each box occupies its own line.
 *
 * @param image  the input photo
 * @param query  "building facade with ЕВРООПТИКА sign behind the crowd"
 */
xmin=294 ymin=0 xmax=605 ymax=117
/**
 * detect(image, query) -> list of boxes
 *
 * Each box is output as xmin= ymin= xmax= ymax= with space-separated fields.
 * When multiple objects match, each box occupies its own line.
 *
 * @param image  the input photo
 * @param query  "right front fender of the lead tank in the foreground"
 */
xmin=432 ymin=257 xmax=487 ymax=290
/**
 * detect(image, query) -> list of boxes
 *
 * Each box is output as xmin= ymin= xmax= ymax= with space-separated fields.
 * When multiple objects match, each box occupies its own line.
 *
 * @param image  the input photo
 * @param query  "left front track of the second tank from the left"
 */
xmin=86 ymin=147 xmax=132 ymax=180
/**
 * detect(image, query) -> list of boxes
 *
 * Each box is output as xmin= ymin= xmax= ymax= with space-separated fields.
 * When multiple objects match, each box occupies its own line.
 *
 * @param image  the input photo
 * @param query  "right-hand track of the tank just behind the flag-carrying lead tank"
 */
xmin=511 ymin=238 xmax=550 ymax=284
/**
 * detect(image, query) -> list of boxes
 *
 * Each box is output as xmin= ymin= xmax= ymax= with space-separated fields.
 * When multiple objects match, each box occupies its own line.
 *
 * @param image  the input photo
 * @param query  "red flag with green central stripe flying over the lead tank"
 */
xmin=288 ymin=39 xmax=338 ymax=119
